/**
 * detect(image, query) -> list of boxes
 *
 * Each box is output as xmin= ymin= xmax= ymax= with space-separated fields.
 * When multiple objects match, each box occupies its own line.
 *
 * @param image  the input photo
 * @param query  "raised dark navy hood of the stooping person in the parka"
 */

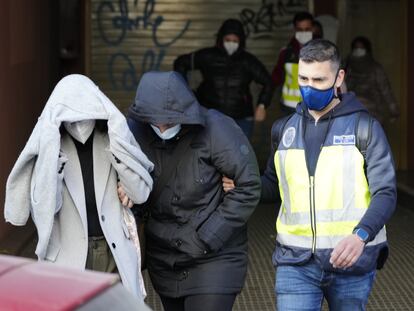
xmin=128 ymin=71 xmax=205 ymax=126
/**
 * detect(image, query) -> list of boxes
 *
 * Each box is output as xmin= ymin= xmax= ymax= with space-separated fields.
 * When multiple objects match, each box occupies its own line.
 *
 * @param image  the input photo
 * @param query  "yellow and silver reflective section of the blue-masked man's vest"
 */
xmin=274 ymin=145 xmax=386 ymax=249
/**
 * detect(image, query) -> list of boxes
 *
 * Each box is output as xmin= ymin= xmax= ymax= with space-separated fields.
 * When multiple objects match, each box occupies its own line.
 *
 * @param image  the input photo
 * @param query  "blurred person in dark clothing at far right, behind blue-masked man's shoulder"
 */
xmin=345 ymin=36 xmax=399 ymax=124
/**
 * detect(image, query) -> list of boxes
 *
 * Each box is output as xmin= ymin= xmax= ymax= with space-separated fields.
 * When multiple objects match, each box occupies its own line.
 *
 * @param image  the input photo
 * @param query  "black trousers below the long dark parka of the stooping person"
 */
xmin=160 ymin=294 xmax=237 ymax=311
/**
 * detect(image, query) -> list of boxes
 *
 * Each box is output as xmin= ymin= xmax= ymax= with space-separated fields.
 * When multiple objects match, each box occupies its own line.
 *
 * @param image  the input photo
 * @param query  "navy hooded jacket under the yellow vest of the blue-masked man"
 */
xmin=261 ymin=93 xmax=397 ymax=274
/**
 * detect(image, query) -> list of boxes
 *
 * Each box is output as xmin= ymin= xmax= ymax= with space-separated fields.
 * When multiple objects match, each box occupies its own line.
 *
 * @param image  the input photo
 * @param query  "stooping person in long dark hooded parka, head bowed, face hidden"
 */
xmin=127 ymin=72 xmax=260 ymax=311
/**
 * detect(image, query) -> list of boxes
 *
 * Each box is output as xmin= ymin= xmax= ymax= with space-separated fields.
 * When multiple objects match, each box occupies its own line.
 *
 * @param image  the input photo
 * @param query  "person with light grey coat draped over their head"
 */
xmin=4 ymin=75 xmax=153 ymax=299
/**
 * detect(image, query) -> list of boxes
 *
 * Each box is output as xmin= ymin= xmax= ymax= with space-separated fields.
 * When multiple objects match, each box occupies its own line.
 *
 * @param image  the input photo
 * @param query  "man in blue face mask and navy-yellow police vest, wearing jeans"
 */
xmin=262 ymin=39 xmax=396 ymax=311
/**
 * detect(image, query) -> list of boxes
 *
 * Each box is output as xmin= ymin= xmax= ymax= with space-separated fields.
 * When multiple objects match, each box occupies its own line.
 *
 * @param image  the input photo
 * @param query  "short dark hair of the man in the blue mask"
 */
xmin=299 ymin=39 xmax=341 ymax=69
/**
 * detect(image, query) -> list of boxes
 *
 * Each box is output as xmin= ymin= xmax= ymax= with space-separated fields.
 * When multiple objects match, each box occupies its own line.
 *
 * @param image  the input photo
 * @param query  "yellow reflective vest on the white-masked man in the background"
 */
xmin=282 ymin=63 xmax=302 ymax=108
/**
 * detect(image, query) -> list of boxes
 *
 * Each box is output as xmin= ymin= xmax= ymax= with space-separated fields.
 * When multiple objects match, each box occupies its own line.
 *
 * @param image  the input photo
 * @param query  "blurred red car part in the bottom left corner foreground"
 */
xmin=0 ymin=255 xmax=151 ymax=311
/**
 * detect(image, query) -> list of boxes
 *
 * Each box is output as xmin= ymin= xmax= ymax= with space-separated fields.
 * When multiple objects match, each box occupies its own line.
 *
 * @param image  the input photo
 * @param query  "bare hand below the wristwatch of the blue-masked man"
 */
xmin=329 ymin=234 xmax=365 ymax=269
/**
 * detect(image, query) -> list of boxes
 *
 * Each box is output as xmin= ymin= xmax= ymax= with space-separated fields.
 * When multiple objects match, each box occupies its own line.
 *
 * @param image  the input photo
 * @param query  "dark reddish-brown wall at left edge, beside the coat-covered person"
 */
xmin=0 ymin=0 xmax=57 ymax=237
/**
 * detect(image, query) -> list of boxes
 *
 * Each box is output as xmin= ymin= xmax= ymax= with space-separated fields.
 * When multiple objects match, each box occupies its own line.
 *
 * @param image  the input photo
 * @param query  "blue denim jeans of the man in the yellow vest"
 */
xmin=275 ymin=260 xmax=376 ymax=311
